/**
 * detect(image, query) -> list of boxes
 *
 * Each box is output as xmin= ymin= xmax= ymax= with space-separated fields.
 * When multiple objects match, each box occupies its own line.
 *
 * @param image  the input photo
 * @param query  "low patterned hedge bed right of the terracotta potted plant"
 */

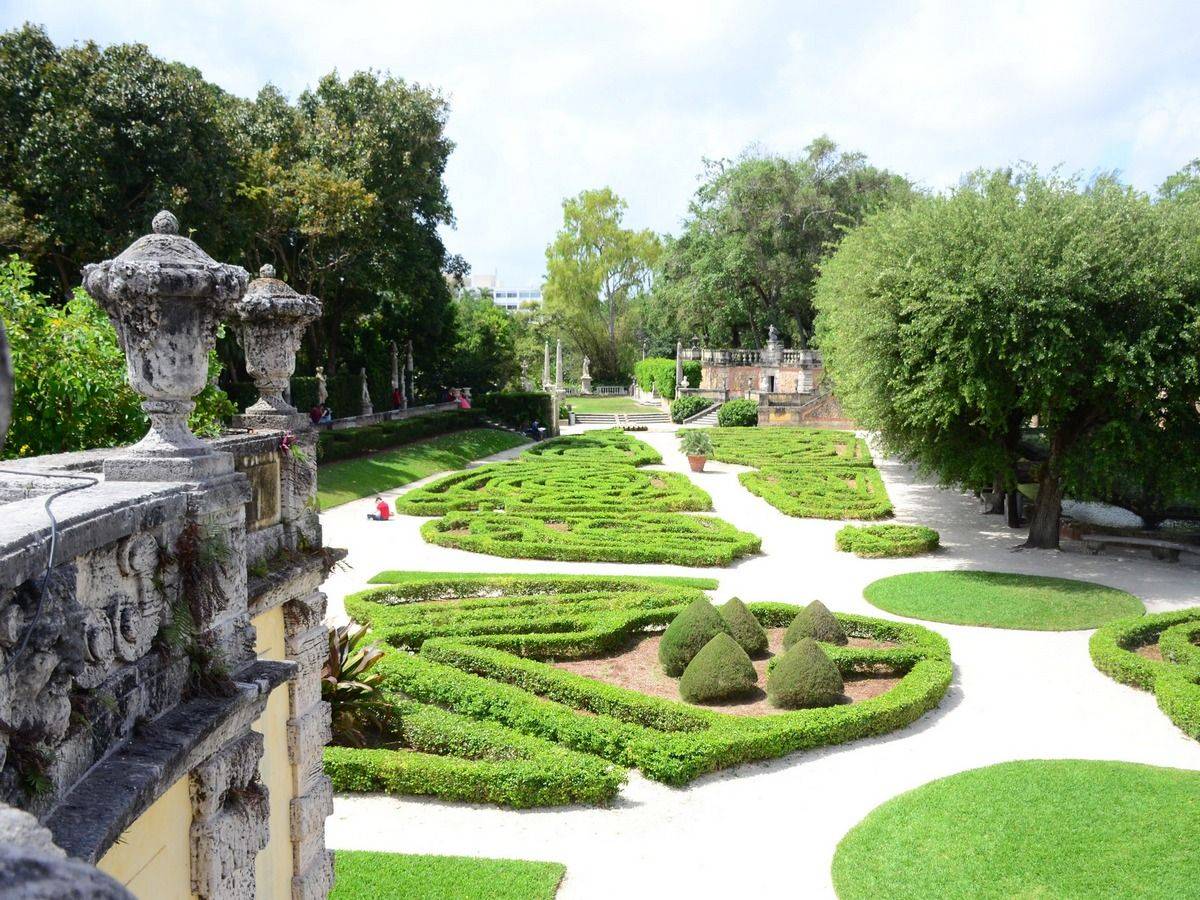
xmin=708 ymin=427 xmax=892 ymax=518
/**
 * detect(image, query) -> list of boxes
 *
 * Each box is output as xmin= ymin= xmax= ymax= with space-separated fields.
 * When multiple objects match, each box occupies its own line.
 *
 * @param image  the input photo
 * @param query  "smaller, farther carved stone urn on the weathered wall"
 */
xmin=234 ymin=263 xmax=320 ymax=430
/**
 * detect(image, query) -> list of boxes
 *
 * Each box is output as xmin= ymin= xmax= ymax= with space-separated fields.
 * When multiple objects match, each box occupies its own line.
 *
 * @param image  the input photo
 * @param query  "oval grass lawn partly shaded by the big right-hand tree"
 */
xmin=863 ymin=571 xmax=1146 ymax=631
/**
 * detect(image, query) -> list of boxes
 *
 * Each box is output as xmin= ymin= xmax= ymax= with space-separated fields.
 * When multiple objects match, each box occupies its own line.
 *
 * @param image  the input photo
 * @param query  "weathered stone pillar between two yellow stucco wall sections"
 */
xmin=190 ymin=730 xmax=269 ymax=900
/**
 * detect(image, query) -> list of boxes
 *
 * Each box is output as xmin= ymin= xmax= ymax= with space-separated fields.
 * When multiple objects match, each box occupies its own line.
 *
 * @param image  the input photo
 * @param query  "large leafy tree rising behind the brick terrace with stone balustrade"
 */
xmin=644 ymin=137 xmax=911 ymax=347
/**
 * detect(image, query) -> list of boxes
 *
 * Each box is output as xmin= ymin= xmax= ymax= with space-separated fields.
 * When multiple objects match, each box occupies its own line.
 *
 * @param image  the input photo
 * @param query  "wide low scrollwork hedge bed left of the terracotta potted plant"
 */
xmin=396 ymin=430 xmax=762 ymax=565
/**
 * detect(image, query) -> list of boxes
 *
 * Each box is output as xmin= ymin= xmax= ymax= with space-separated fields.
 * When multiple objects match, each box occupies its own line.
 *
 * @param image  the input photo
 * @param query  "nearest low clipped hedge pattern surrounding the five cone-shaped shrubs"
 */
xmin=325 ymin=572 xmax=950 ymax=806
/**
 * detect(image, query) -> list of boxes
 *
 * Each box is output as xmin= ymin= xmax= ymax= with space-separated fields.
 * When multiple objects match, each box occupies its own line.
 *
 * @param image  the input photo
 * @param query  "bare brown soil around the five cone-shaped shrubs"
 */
xmin=553 ymin=628 xmax=900 ymax=715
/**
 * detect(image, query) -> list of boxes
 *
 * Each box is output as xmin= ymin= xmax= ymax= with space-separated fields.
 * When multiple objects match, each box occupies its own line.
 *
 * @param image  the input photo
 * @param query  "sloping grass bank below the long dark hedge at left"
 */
xmin=317 ymin=428 xmax=524 ymax=509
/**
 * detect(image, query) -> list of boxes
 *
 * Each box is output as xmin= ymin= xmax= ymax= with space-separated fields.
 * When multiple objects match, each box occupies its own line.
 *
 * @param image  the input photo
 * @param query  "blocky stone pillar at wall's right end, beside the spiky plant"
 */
xmin=283 ymin=590 xmax=334 ymax=900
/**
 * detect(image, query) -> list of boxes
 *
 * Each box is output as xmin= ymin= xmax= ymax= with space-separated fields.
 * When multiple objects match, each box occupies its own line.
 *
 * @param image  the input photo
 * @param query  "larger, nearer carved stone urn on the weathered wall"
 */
xmin=83 ymin=210 xmax=248 ymax=481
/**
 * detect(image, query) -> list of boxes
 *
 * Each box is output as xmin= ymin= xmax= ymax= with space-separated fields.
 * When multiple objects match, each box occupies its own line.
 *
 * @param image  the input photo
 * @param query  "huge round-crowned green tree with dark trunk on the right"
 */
xmin=816 ymin=170 xmax=1200 ymax=547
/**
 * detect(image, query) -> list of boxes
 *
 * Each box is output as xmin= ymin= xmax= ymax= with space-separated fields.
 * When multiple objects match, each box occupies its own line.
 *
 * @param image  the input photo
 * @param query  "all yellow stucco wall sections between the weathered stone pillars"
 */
xmin=98 ymin=606 xmax=293 ymax=900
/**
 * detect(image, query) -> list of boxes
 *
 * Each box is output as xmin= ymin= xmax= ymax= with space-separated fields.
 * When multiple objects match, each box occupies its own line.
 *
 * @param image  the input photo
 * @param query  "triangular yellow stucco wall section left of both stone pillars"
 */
xmin=97 ymin=775 xmax=193 ymax=900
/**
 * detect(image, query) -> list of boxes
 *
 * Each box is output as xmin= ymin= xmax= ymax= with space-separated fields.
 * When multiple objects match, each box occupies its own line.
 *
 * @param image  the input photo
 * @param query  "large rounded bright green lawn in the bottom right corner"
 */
xmin=833 ymin=760 xmax=1200 ymax=900
